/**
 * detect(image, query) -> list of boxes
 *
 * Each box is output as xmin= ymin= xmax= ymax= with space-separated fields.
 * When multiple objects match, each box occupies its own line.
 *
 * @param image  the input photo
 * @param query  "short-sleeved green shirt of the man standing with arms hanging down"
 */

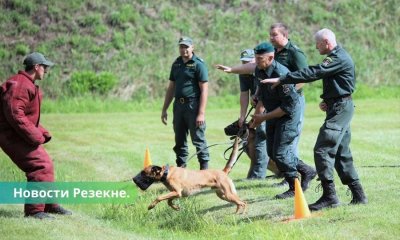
xmin=169 ymin=54 xmax=208 ymax=99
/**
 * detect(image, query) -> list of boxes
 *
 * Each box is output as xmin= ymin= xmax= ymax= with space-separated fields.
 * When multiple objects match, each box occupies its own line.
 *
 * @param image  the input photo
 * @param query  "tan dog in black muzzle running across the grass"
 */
xmin=141 ymin=166 xmax=246 ymax=213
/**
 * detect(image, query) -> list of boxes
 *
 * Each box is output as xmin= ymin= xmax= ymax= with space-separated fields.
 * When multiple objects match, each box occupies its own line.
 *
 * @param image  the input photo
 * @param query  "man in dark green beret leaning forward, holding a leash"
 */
xmin=251 ymin=42 xmax=300 ymax=199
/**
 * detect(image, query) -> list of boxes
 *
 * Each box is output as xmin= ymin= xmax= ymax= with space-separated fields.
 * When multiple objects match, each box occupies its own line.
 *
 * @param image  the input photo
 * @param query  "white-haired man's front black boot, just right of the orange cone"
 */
xmin=308 ymin=181 xmax=339 ymax=211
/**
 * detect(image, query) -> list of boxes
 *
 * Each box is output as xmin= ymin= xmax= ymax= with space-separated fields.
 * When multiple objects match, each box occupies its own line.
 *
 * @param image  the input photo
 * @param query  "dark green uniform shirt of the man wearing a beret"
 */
xmin=255 ymin=61 xmax=299 ymax=117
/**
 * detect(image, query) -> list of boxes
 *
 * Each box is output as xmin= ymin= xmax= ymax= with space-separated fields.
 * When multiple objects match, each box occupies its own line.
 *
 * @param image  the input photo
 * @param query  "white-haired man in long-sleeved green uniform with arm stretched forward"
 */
xmin=262 ymin=28 xmax=368 ymax=211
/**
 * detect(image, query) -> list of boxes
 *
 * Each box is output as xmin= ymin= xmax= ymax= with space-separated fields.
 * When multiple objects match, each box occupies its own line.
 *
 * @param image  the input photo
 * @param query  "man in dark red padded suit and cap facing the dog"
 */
xmin=0 ymin=52 xmax=72 ymax=219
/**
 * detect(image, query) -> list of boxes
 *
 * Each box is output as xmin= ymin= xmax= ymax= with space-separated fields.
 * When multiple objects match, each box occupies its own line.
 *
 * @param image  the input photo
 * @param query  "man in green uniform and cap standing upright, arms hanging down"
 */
xmin=161 ymin=37 xmax=210 ymax=169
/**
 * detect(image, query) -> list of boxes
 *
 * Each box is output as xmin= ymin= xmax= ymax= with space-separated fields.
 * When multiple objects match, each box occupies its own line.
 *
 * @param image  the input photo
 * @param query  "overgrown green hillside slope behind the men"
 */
xmin=0 ymin=0 xmax=400 ymax=101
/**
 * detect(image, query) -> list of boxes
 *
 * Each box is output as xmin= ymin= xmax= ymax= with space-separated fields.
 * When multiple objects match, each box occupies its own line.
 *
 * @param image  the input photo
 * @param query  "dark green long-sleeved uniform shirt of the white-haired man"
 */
xmin=279 ymin=46 xmax=356 ymax=99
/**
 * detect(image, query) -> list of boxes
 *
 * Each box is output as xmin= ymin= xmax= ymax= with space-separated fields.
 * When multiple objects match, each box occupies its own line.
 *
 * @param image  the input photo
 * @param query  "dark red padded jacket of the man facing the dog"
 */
xmin=0 ymin=71 xmax=50 ymax=146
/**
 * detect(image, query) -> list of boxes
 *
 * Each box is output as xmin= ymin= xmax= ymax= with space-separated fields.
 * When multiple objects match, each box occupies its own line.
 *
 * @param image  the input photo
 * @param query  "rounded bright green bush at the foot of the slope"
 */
xmin=67 ymin=71 xmax=117 ymax=96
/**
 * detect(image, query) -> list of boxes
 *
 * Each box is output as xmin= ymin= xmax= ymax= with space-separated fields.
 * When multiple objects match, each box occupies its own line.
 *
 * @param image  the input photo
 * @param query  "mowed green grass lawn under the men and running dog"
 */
xmin=0 ymin=99 xmax=400 ymax=240
